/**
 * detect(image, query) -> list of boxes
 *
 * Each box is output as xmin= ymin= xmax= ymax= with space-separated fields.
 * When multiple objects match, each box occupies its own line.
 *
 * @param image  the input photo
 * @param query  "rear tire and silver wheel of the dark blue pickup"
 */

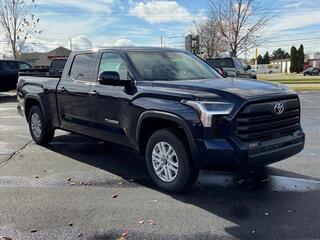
xmin=28 ymin=106 xmax=54 ymax=145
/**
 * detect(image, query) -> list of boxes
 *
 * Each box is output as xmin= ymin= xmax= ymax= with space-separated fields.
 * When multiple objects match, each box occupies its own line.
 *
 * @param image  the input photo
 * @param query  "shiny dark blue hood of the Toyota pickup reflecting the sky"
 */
xmin=146 ymin=78 xmax=295 ymax=100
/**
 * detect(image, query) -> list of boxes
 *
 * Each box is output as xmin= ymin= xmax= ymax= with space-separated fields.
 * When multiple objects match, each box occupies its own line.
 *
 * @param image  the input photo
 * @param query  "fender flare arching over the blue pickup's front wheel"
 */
xmin=136 ymin=110 xmax=196 ymax=159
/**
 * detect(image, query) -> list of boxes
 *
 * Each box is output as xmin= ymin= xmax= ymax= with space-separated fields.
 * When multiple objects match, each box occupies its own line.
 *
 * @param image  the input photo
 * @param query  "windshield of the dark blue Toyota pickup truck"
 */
xmin=128 ymin=51 xmax=220 ymax=81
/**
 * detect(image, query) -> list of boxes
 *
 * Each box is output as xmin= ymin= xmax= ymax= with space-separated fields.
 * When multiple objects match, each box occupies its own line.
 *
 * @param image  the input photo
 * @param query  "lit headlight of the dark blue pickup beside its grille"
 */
xmin=181 ymin=100 xmax=234 ymax=127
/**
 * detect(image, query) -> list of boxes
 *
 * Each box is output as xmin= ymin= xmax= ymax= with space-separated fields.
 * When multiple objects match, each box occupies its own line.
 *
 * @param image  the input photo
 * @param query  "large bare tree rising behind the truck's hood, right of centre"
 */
xmin=209 ymin=0 xmax=272 ymax=56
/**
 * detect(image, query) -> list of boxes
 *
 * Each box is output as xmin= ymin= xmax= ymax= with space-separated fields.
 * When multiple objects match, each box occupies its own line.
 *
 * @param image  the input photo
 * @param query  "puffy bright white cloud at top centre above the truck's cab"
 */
xmin=129 ymin=0 xmax=192 ymax=23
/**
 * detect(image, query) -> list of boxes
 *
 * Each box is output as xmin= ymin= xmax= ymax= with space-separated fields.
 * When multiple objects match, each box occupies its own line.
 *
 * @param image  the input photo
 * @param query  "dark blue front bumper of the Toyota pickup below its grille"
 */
xmin=196 ymin=131 xmax=305 ymax=169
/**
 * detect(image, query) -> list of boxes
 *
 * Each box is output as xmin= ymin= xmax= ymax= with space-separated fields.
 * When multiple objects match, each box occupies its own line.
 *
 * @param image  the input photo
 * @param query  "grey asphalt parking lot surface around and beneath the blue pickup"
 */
xmin=0 ymin=92 xmax=320 ymax=240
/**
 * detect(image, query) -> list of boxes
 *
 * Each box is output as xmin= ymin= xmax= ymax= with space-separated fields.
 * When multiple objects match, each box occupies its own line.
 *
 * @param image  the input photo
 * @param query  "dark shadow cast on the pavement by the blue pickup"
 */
xmin=48 ymin=134 xmax=320 ymax=239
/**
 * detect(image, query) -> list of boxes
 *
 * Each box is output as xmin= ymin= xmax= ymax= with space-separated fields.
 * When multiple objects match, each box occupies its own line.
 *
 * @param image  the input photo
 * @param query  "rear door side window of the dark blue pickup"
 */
xmin=69 ymin=53 xmax=97 ymax=82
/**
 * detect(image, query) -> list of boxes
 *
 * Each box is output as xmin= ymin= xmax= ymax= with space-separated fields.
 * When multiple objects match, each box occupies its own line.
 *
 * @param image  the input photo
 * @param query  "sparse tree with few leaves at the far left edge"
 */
xmin=0 ymin=0 xmax=41 ymax=59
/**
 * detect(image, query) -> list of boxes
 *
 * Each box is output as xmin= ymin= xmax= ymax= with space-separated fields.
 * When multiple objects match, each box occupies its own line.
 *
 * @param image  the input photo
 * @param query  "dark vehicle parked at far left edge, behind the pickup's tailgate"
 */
xmin=0 ymin=60 xmax=31 ymax=91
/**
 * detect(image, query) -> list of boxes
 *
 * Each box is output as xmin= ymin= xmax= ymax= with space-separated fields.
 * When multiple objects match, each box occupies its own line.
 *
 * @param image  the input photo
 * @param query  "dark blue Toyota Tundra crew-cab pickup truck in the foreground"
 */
xmin=18 ymin=47 xmax=305 ymax=192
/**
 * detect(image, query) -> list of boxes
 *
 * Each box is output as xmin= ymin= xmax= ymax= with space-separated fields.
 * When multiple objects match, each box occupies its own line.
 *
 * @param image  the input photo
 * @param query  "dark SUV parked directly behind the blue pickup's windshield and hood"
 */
xmin=206 ymin=57 xmax=257 ymax=79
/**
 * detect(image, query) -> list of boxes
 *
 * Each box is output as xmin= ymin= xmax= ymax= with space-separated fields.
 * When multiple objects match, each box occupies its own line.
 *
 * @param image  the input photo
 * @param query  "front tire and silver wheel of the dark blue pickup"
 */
xmin=146 ymin=129 xmax=199 ymax=193
